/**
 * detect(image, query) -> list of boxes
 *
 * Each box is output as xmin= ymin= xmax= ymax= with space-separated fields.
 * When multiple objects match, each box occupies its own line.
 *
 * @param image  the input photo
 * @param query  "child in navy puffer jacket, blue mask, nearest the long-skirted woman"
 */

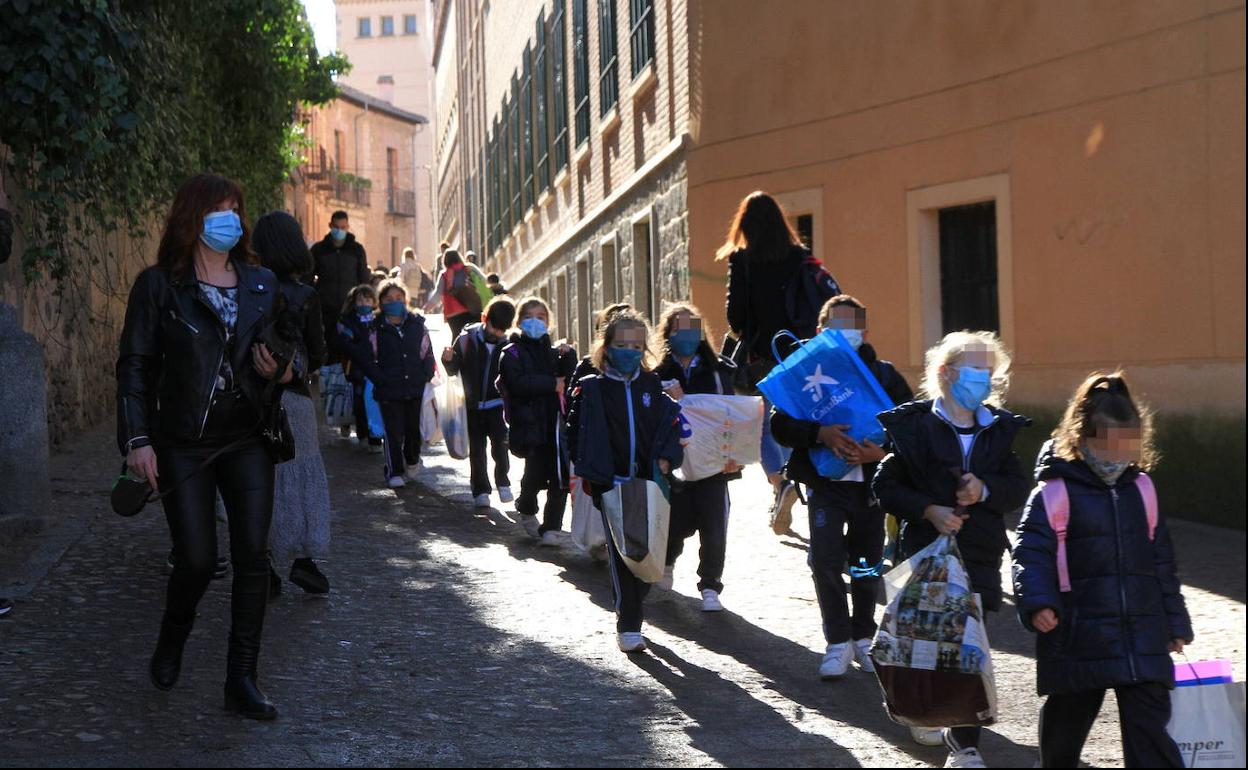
xmin=351 ymin=280 xmax=433 ymax=489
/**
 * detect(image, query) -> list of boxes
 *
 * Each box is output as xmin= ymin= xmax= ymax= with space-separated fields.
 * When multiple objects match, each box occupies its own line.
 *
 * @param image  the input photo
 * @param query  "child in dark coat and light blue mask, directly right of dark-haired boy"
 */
xmin=498 ymin=297 xmax=577 ymax=548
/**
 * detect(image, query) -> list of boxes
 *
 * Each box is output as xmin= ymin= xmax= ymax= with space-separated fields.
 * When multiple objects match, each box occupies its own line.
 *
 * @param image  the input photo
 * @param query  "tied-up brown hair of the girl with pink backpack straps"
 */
xmin=1053 ymin=372 xmax=1158 ymax=470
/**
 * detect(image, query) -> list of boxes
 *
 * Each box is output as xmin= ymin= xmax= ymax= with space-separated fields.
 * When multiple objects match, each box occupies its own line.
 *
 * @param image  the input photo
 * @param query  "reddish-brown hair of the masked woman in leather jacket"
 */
xmin=156 ymin=173 xmax=260 ymax=278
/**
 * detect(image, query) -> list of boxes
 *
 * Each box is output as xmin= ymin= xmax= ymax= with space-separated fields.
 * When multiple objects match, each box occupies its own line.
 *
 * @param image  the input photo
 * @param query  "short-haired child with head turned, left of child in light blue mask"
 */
xmin=442 ymin=297 xmax=515 ymax=508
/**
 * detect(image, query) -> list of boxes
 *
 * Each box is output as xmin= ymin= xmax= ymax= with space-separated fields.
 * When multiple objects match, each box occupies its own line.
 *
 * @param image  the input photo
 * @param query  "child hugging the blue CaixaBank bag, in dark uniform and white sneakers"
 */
xmin=771 ymin=295 xmax=915 ymax=679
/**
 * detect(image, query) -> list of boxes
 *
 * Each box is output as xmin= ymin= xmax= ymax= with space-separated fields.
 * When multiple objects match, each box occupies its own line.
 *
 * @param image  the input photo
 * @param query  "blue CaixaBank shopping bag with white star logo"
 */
xmin=759 ymin=329 xmax=894 ymax=479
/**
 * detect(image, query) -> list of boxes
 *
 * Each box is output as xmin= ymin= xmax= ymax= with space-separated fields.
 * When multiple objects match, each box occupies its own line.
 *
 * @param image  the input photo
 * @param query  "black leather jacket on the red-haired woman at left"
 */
xmin=117 ymin=262 xmax=277 ymax=453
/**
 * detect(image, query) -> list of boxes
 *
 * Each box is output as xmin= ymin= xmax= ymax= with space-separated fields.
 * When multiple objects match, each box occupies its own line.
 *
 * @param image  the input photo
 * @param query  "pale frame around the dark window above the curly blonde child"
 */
xmin=906 ymin=173 xmax=1015 ymax=367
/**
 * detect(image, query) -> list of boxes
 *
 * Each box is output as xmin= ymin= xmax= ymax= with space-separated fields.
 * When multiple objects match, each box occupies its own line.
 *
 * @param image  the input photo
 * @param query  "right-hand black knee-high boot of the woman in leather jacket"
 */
xmin=225 ymin=553 xmax=277 ymax=720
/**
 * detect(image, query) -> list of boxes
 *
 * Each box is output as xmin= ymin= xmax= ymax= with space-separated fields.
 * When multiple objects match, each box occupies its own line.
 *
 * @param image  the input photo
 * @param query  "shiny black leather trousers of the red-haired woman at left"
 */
xmin=156 ymin=389 xmax=273 ymax=676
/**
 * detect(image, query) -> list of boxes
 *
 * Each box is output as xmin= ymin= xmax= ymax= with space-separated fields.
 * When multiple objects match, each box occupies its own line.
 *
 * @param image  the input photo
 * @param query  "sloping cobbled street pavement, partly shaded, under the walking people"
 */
xmin=0 ymin=416 xmax=1244 ymax=766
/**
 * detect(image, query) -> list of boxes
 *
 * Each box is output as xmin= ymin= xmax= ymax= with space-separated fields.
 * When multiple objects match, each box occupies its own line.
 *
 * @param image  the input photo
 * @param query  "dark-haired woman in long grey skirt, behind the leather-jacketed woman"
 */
xmin=251 ymin=211 xmax=329 ymax=597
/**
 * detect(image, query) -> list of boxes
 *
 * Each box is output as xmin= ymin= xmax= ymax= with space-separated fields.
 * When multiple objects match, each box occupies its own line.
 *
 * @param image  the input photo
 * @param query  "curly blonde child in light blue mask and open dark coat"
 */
xmin=872 ymin=332 xmax=1031 ymax=768
